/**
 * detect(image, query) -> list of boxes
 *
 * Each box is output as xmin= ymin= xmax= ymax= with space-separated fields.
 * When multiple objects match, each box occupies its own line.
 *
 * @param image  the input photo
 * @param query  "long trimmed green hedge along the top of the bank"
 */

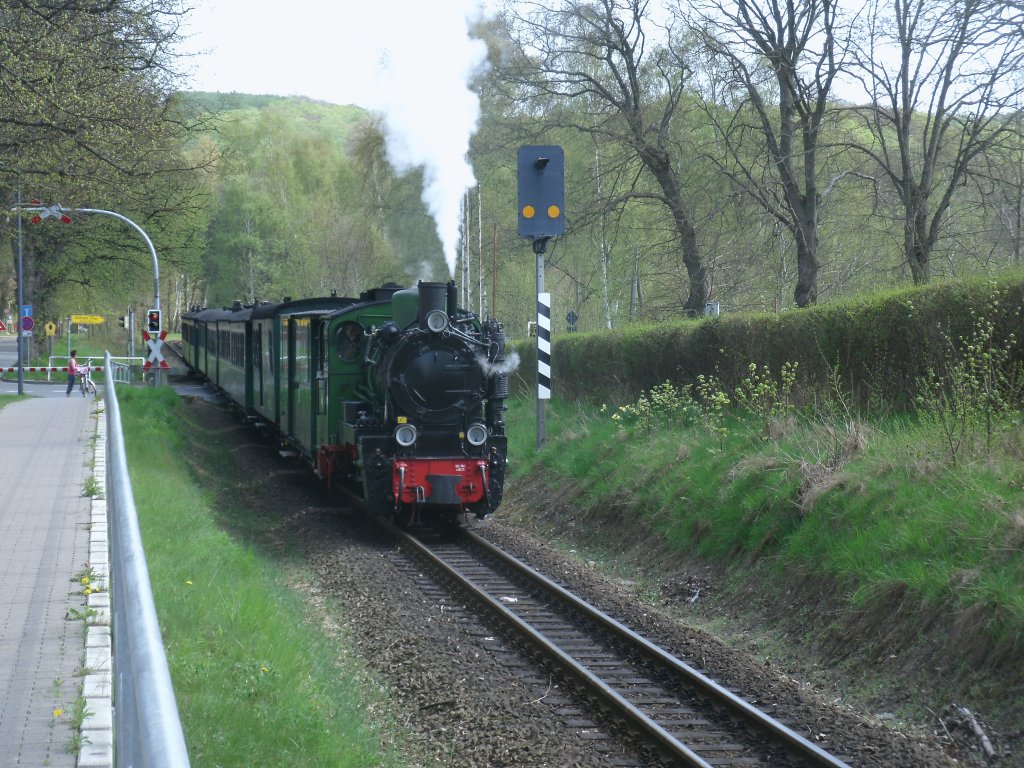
xmin=513 ymin=275 xmax=1024 ymax=408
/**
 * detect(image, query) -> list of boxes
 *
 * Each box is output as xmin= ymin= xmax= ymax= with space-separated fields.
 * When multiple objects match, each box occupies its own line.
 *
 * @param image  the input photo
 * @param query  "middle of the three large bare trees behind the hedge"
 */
xmin=693 ymin=0 xmax=840 ymax=306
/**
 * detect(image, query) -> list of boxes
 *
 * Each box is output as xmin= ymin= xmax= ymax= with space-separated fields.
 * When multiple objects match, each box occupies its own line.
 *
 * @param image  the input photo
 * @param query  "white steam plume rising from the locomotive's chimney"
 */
xmin=373 ymin=0 xmax=486 ymax=276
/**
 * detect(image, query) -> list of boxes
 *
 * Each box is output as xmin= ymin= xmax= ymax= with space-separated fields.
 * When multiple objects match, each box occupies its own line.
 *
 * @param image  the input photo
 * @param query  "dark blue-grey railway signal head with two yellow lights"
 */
xmin=516 ymin=145 xmax=565 ymax=238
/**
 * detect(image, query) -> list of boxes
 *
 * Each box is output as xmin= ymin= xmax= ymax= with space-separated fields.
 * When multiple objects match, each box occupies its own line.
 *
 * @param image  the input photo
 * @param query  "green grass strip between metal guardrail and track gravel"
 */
xmin=118 ymin=387 xmax=397 ymax=768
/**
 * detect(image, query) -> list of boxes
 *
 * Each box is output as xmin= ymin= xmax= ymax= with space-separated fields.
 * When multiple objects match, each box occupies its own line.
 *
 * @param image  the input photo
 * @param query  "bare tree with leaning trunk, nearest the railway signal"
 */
xmin=499 ymin=0 xmax=709 ymax=313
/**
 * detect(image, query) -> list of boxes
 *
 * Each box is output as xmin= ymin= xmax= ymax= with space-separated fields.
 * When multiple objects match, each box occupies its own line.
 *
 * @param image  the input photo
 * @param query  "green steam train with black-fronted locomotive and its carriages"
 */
xmin=181 ymin=282 xmax=509 ymax=525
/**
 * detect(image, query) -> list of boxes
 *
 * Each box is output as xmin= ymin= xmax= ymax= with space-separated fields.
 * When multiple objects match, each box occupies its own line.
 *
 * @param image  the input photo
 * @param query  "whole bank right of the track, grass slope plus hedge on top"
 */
xmin=502 ymin=274 xmax=1024 ymax=765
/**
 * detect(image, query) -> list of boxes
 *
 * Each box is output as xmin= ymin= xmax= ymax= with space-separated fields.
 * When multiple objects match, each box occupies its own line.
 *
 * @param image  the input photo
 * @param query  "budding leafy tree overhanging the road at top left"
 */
xmin=0 ymin=0 xmax=209 ymax=323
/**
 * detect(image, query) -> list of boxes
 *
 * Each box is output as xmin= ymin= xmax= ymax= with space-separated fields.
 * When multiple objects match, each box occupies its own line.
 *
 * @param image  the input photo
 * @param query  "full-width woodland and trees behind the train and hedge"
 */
xmin=0 ymin=0 xmax=1024 ymax=337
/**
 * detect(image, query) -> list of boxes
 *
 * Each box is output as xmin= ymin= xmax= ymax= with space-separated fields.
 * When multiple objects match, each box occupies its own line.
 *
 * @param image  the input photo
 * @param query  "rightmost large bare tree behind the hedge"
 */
xmin=851 ymin=0 xmax=1024 ymax=284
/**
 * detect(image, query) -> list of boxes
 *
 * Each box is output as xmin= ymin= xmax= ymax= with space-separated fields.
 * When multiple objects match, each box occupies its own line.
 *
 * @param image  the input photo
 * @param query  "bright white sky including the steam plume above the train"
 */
xmin=179 ymin=0 xmax=495 ymax=273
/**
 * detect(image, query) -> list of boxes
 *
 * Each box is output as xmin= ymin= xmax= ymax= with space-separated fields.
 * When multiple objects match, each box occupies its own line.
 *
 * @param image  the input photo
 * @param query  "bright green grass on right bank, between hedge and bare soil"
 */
xmin=507 ymin=399 xmax=1024 ymax=645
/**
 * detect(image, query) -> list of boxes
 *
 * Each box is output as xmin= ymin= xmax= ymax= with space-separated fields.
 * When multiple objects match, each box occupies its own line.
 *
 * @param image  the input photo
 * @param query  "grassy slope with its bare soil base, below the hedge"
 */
xmin=504 ymin=387 xmax=1024 ymax=723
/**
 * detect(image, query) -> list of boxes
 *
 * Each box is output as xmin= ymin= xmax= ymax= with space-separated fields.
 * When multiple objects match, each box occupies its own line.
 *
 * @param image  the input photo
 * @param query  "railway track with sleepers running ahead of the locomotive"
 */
xmin=393 ymin=529 xmax=849 ymax=768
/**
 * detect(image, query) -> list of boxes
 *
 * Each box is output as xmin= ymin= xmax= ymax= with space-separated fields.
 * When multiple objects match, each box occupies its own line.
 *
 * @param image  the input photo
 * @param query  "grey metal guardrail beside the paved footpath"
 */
xmin=104 ymin=354 xmax=189 ymax=768
